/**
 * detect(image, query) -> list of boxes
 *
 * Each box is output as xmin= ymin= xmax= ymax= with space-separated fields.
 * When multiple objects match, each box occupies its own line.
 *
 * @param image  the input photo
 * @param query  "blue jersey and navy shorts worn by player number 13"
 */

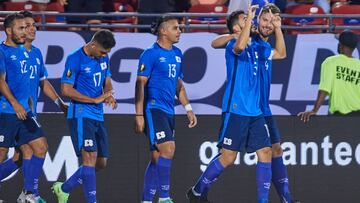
xmin=138 ymin=43 xmax=183 ymax=150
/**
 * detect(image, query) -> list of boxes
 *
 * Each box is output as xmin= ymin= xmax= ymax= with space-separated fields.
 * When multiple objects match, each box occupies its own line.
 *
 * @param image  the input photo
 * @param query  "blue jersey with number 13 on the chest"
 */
xmin=138 ymin=43 xmax=183 ymax=114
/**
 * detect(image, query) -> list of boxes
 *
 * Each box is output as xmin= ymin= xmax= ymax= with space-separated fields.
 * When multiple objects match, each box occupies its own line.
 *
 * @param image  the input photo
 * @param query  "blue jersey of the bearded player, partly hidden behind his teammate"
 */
xmin=252 ymin=35 xmax=273 ymax=116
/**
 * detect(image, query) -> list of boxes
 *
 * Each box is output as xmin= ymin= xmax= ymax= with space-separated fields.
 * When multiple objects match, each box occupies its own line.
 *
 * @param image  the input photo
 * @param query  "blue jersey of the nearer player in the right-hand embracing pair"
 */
xmin=222 ymin=39 xmax=262 ymax=116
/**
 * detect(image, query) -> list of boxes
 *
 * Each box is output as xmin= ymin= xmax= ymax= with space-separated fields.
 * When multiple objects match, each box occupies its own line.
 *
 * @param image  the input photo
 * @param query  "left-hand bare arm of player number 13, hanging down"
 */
xmin=134 ymin=76 xmax=148 ymax=133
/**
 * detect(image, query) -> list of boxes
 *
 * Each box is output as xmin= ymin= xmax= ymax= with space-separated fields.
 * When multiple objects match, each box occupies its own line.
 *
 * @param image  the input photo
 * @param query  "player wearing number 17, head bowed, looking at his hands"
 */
xmin=52 ymin=29 xmax=117 ymax=203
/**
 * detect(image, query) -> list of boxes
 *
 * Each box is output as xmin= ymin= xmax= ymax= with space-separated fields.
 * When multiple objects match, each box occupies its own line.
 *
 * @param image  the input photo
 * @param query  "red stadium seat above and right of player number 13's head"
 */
xmin=189 ymin=4 xmax=227 ymax=32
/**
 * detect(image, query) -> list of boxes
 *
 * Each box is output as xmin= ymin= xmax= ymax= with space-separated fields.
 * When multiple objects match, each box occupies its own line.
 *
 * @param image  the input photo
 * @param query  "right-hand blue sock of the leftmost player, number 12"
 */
xmin=24 ymin=155 xmax=45 ymax=193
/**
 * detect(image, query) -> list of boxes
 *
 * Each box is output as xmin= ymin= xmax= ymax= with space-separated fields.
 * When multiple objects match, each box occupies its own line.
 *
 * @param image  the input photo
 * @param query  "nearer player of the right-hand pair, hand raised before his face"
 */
xmin=187 ymin=5 xmax=271 ymax=203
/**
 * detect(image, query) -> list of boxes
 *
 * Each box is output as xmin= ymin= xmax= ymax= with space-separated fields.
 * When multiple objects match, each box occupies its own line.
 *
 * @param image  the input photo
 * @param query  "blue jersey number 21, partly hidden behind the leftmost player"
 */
xmin=27 ymin=46 xmax=48 ymax=114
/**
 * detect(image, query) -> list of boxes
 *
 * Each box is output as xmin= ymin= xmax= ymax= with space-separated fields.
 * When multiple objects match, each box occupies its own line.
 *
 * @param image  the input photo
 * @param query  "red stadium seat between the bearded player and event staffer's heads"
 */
xmin=284 ymin=5 xmax=327 ymax=34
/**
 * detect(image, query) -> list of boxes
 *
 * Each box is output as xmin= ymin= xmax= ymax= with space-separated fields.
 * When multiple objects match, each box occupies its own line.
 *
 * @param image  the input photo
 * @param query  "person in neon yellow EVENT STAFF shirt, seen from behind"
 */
xmin=298 ymin=30 xmax=360 ymax=119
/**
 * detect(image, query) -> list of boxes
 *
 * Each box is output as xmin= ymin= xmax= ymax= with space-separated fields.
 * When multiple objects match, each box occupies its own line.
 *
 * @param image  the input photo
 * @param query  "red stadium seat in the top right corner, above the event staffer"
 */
xmin=331 ymin=3 xmax=360 ymax=34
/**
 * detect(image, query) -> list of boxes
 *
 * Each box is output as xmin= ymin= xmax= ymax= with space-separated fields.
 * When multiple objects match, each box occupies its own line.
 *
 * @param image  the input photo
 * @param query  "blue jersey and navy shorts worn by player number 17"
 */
xmin=61 ymin=47 xmax=111 ymax=157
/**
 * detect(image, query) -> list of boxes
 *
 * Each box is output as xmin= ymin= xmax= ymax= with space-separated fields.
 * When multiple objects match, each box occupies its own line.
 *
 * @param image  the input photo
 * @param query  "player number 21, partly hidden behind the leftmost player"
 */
xmin=13 ymin=11 xmax=67 ymax=203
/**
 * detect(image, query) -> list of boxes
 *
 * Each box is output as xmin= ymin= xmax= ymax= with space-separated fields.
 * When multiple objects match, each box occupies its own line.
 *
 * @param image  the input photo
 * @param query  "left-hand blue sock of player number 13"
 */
xmin=142 ymin=161 xmax=158 ymax=201
